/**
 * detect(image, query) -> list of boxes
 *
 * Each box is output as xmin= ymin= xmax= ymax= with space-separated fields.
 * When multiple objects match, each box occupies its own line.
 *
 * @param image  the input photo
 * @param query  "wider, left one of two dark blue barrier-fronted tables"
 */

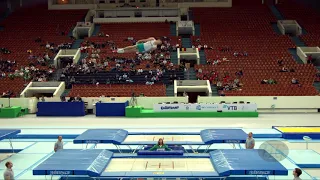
xmin=37 ymin=102 xmax=86 ymax=116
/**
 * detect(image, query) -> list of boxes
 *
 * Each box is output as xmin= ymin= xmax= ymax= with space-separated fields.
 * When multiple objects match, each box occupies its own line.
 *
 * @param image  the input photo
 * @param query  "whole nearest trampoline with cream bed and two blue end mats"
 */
xmin=33 ymin=149 xmax=288 ymax=178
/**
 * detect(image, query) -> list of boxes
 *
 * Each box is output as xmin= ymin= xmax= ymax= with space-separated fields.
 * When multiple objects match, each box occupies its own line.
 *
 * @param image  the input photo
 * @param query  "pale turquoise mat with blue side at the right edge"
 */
xmin=288 ymin=150 xmax=320 ymax=168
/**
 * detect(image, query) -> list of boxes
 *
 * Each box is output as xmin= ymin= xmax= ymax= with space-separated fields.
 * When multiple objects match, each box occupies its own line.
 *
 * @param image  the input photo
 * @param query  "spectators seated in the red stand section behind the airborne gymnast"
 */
xmin=61 ymin=35 xmax=181 ymax=85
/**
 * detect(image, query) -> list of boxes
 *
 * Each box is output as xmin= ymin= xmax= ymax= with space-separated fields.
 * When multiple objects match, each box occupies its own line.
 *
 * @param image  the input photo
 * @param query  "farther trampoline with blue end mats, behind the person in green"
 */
xmin=73 ymin=129 xmax=247 ymax=153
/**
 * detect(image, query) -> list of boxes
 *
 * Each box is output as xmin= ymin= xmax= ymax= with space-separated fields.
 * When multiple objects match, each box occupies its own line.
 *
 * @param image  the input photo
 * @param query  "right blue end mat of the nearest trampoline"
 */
xmin=209 ymin=149 xmax=288 ymax=176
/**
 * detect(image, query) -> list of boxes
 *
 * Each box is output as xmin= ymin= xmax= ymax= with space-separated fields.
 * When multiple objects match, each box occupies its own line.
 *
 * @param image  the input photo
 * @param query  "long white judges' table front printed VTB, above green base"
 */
xmin=153 ymin=103 xmax=258 ymax=112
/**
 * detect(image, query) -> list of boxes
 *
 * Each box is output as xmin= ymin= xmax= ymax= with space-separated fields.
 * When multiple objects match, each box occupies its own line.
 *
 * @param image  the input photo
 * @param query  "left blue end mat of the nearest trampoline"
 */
xmin=33 ymin=149 xmax=113 ymax=177
